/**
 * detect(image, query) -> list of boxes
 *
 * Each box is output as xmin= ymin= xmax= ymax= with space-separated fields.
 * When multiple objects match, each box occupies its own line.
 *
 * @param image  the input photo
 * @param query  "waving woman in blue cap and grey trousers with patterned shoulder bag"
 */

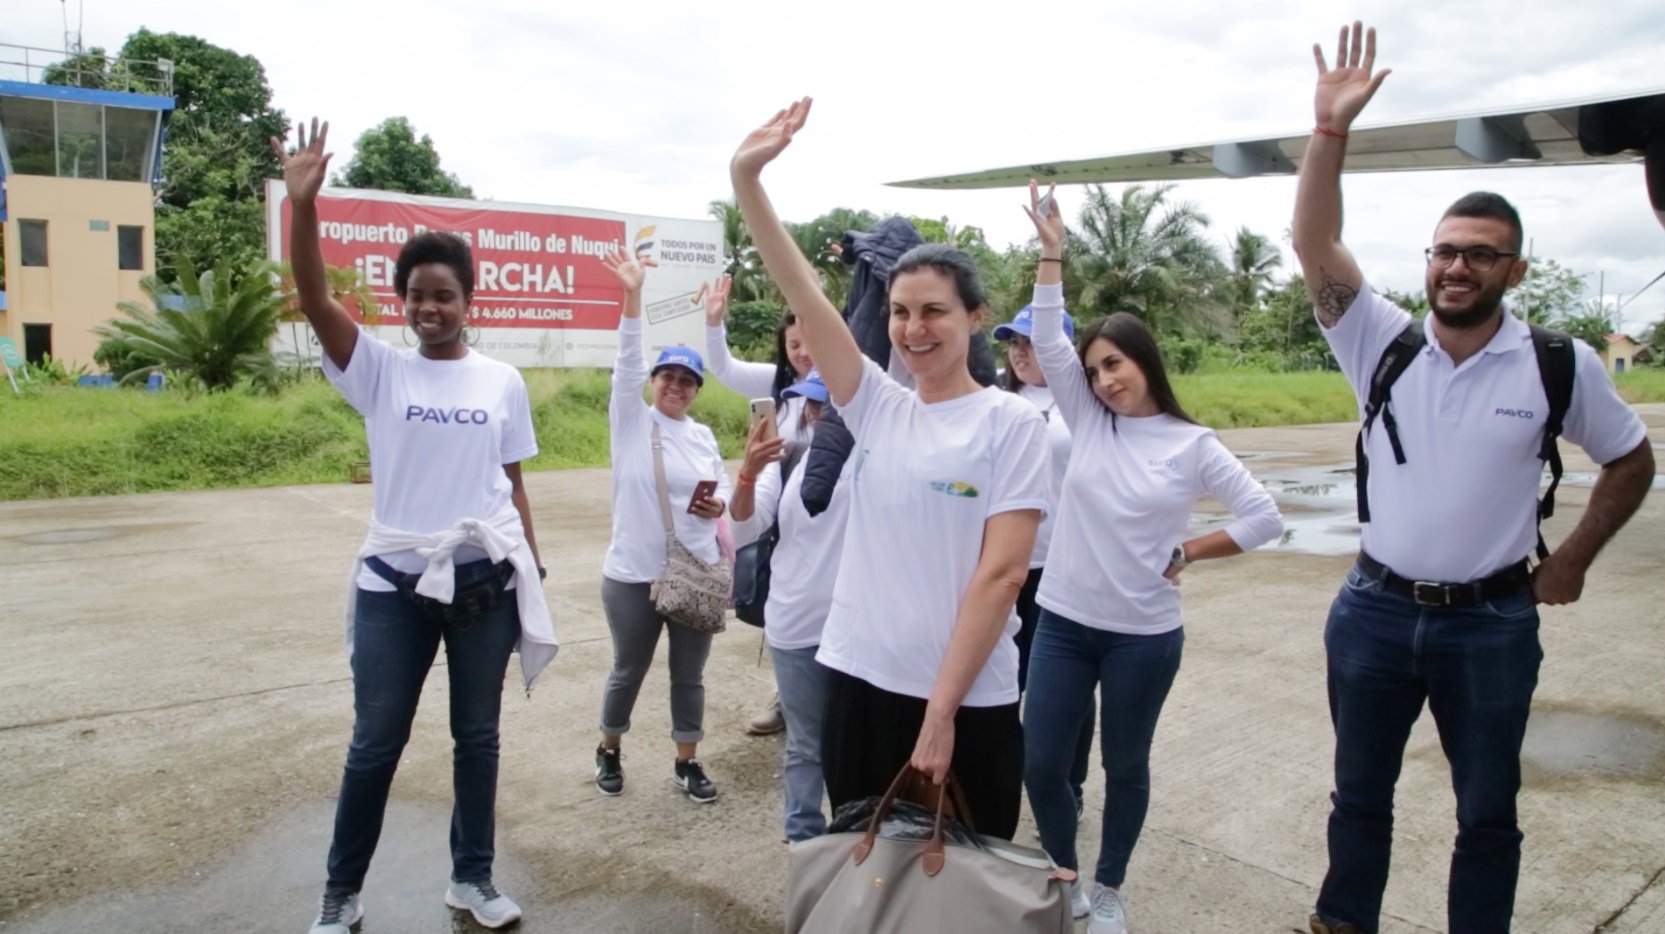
xmin=596 ymin=253 xmax=729 ymax=804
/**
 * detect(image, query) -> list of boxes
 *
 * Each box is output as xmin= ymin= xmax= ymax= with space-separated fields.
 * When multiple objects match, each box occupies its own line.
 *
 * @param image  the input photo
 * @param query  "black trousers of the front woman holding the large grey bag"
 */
xmin=821 ymin=669 xmax=1024 ymax=839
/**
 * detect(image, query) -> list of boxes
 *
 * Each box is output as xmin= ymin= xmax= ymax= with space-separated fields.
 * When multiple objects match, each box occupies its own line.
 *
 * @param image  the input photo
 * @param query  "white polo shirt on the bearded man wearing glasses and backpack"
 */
xmin=1324 ymin=285 xmax=1647 ymax=583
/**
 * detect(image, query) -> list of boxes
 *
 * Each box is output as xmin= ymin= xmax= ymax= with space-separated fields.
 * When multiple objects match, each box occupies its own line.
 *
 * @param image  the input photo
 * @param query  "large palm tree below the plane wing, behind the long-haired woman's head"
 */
xmin=1066 ymin=185 xmax=1225 ymax=331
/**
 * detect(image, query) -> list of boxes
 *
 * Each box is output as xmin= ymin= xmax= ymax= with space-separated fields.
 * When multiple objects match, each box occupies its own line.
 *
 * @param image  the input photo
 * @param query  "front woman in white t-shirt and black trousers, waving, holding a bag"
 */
xmin=731 ymin=98 xmax=1049 ymax=839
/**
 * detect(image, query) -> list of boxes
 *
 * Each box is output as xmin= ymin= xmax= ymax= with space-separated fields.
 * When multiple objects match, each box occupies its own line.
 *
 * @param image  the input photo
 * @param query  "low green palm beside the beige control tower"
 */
xmin=93 ymin=258 xmax=285 ymax=391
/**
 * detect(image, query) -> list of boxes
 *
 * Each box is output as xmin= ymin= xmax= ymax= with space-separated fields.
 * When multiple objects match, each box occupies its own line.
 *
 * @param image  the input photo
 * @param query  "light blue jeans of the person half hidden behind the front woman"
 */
xmin=769 ymin=646 xmax=831 ymax=842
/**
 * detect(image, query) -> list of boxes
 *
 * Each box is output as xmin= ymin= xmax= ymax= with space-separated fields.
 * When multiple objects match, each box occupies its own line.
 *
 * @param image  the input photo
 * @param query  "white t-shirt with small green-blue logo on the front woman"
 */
xmin=816 ymin=360 xmax=1049 ymax=708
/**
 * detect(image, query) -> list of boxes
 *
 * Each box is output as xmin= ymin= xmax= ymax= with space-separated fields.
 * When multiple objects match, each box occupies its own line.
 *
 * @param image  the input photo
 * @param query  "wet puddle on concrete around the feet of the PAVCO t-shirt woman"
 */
xmin=0 ymin=801 xmax=764 ymax=934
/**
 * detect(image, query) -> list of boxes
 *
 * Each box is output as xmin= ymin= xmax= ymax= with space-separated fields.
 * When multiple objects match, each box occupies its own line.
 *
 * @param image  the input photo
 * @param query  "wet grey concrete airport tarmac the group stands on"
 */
xmin=0 ymin=406 xmax=1665 ymax=934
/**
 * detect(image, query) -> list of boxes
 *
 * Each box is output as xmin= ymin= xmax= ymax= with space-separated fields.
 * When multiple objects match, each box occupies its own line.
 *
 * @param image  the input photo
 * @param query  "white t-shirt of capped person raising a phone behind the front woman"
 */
xmin=736 ymin=449 xmax=851 ymax=649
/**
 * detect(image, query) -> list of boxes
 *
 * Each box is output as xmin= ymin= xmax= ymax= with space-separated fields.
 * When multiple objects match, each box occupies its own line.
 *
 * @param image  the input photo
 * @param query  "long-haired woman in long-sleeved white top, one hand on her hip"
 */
xmin=1024 ymin=181 xmax=1284 ymax=934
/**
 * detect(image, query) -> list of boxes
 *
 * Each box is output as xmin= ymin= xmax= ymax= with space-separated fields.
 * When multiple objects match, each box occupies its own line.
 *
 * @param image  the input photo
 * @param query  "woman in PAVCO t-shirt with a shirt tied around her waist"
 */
xmin=271 ymin=120 xmax=556 ymax=934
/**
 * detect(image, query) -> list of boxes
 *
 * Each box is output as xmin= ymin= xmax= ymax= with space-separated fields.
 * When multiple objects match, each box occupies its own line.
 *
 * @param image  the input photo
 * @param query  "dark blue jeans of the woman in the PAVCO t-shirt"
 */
xmin=326 ymin=561 xmax=519 ymax=892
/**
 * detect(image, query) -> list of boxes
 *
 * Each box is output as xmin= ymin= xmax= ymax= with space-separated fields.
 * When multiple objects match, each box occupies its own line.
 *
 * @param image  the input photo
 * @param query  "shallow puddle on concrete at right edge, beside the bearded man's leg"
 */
xmin=1520 ymin=709 xmax=1665 ymax=781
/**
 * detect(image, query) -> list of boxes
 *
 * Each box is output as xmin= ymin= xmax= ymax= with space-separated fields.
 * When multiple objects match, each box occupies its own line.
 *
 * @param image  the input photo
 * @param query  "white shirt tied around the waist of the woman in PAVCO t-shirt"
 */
xmin=346 ymin=503 xmax=561 ymax=694
